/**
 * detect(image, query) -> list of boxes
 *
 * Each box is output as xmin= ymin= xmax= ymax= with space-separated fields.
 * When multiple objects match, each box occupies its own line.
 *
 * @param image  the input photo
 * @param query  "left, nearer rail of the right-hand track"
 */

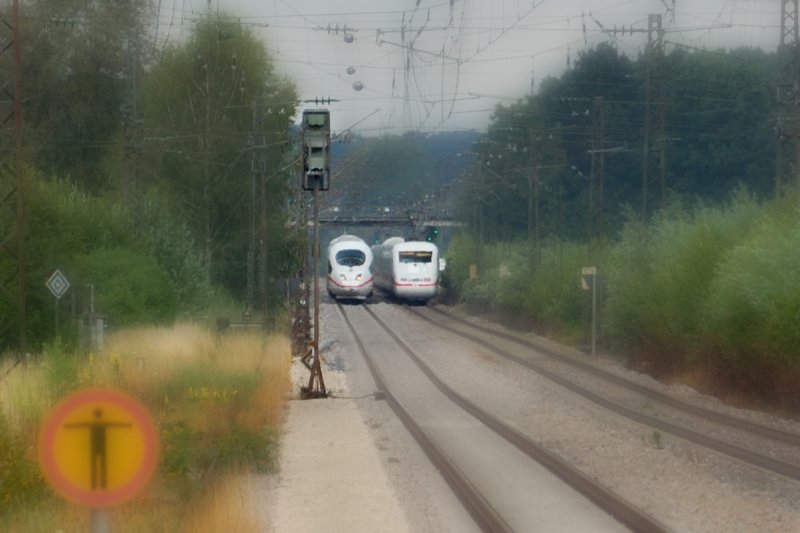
xmin=411 ymin=304 xmax=800 ymax=481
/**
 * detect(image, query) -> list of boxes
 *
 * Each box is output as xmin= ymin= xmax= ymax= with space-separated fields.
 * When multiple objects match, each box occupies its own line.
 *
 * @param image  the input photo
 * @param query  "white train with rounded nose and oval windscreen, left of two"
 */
xmin=327 ymin=235 xmax=372 ymax=300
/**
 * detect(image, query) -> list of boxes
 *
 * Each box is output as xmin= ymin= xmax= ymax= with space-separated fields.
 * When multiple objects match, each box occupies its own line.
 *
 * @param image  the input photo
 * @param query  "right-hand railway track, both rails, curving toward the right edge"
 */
xmin=404 ymin=307 xmax=800 ymax=481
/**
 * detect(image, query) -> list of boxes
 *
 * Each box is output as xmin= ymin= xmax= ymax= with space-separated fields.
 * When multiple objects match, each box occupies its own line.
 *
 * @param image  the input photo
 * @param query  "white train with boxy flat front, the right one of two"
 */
xmin=372 ymin=237 xmax=441 ymax=301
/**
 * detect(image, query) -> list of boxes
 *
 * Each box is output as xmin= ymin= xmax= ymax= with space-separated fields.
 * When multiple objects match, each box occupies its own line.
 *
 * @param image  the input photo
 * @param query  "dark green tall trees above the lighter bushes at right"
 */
xmin=455 ymin=44 xmax=777 ymax=241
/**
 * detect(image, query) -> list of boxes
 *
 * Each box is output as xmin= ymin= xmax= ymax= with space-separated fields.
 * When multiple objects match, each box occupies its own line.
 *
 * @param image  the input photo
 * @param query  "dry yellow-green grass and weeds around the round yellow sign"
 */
xmin=0 ymin=325 xmax=291 ymax=532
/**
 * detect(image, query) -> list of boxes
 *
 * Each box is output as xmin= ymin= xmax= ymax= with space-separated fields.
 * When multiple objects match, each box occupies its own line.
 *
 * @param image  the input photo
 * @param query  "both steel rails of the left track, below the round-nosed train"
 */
xmin=337 ymin=304 xmax=669 ymax=532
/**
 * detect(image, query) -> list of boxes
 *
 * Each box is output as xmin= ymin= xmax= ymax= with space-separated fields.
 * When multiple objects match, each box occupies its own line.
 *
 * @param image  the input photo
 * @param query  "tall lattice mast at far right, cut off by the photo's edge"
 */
xmin=775 ymin=0 xmax=800 ymax=196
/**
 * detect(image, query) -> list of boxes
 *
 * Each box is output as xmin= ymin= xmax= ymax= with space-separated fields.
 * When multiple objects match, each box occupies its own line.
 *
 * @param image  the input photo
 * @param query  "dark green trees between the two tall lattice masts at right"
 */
xmin=666 ymin=48 xmax=778 ymax=200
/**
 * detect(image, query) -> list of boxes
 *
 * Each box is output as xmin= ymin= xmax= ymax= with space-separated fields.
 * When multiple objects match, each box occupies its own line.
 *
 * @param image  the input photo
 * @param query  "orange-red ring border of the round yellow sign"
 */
xmin=39 ymin=389 xmax=158 ymax=508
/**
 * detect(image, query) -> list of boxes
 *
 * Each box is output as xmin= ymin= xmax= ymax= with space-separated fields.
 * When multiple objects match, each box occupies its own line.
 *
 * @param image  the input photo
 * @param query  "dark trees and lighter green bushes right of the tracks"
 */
xmin=445 ymin=43 xmax=800 ymax=413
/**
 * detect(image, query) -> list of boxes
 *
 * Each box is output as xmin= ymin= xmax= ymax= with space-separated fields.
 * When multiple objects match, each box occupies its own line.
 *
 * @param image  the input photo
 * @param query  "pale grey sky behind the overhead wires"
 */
xmin=136 ymin=0 xmax=778 ymax=136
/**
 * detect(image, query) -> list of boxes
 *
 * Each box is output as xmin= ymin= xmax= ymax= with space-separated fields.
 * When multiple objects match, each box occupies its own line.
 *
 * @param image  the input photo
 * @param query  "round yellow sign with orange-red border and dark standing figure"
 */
xmin=39 ymin=389 xmax=158 ymax=508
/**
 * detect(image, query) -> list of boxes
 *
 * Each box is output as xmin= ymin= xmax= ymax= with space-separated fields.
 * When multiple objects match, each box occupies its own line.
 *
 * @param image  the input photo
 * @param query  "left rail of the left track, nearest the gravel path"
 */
xmin=336 ymin=303 xmax=513 ymax=533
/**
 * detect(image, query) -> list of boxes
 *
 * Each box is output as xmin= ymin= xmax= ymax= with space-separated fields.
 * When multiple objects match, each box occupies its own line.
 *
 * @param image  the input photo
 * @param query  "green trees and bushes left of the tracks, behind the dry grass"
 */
xmin=0 ymin=4 xmax=300 ymax=351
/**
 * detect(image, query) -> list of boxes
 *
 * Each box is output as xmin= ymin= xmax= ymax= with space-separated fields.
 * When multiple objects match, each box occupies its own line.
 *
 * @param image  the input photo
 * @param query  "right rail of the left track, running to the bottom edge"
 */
xmin=356 ymin=307 xmax=670 ymax=533
